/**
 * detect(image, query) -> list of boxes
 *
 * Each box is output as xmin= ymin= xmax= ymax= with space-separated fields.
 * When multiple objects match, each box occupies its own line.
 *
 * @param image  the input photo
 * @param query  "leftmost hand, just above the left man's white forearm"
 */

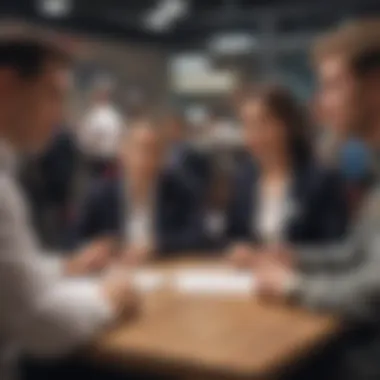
xmin=65 ymin=238 xmax=113 ymax=276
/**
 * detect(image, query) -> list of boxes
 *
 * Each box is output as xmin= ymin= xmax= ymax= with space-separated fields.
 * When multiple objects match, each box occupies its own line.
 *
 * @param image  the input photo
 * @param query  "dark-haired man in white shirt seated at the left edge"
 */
xmin=0 ymin=36 xmax=135 ymax=380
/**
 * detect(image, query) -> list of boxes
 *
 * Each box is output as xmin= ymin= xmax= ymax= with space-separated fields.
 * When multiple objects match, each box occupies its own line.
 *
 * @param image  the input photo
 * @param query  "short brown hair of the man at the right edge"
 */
xmin=312 ymin=19 xmax=380 ymax=76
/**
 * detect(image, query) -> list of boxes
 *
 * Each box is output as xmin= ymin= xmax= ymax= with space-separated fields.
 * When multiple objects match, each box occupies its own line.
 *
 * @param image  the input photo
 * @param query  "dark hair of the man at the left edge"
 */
xmin=0 ymin=37 xmax=70 ymax=79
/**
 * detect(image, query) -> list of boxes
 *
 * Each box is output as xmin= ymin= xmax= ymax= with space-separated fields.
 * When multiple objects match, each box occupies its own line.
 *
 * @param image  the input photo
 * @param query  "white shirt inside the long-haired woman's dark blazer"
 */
xmin=254 ymin=181 xmax=289 ymax=244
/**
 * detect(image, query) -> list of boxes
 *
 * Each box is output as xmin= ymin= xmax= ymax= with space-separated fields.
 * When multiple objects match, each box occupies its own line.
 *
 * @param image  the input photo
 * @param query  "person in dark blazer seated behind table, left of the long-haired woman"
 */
xmin=76 ymin=119 xmax=205 ymax=262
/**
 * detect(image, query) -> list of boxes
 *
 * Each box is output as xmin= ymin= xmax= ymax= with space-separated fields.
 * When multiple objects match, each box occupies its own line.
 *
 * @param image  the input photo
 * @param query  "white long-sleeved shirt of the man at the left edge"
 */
xmin=0 ymin=142 xmax=114 ymax=380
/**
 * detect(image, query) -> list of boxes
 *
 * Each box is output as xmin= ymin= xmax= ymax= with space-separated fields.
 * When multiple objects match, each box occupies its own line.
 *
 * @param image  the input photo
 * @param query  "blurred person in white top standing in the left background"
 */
xmin=79 ymin=79 xmax=124 ymax=179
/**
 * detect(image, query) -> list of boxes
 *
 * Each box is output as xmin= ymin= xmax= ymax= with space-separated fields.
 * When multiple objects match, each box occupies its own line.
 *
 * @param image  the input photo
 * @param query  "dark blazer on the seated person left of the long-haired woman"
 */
xmin=75 ymin=173 xmax=202 ymax=254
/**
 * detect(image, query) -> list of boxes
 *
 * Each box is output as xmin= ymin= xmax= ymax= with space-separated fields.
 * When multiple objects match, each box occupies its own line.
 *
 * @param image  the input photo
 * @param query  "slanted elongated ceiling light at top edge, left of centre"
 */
xmin=144 ymin=0 xmax=189 ymax=31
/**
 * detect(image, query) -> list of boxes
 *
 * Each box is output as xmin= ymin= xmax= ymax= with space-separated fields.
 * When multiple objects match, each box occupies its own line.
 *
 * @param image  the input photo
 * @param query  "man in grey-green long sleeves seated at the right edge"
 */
xmin=254 ymin=18 xmax=380 ymax=380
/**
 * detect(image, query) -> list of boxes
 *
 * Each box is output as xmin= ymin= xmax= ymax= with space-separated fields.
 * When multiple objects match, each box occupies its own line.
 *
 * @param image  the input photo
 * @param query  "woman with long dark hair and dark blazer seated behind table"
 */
xmin=227 ymin=85 xmax=347 ymax=264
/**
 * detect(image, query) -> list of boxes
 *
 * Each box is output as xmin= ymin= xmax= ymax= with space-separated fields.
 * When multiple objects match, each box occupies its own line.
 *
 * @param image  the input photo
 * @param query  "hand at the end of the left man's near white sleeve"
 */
xmin=101 ymin=271 xmax=140 ymax=318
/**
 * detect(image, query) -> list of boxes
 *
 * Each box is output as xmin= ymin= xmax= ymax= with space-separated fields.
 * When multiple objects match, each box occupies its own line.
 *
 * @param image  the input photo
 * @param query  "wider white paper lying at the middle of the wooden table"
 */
xmin=174 ymin=269 xmax=255 ymax=296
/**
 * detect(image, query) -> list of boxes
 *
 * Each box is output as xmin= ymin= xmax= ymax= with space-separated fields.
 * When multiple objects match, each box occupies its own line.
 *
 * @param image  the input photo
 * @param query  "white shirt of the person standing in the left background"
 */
xmin=79 ymin=103 xmax=123 ymax=159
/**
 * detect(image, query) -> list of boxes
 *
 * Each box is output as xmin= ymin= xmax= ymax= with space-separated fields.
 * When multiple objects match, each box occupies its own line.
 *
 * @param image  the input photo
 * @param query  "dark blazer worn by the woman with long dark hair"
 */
xmin=227 ymin=160 xmax=348 ymax=243
